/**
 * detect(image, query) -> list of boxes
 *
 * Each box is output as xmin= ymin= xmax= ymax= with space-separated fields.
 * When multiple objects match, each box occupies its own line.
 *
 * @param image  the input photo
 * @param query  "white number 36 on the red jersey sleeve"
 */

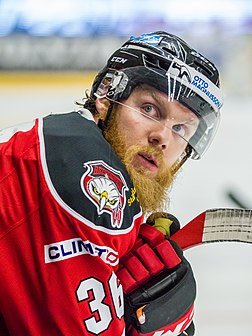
xmin=76 ymin=273 xmax=124 ymax=334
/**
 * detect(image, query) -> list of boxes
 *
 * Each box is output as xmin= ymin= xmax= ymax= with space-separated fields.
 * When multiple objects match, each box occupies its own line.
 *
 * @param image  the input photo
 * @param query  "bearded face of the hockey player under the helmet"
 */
xmin=105 ymin=85 xmax=198 ymax=212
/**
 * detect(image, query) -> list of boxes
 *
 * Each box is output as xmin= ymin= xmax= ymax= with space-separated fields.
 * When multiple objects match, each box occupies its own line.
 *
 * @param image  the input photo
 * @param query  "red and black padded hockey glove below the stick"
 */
xmin=117 ymin=214 xmax=196 ymax=336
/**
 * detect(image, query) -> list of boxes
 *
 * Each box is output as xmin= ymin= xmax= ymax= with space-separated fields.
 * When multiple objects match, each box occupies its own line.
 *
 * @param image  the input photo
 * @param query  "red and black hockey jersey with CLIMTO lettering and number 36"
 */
xmin=0 ymin=112 xmax=143 ymax=336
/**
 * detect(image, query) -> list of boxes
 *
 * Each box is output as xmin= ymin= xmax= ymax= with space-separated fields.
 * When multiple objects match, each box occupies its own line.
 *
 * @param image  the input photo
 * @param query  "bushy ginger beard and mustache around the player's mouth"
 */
xmin=104 ymin=113 xmax=174 ymax=214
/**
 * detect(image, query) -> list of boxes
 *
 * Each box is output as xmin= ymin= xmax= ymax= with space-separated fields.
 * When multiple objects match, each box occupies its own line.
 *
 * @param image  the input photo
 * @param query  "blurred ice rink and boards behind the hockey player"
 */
xmin=0 ymin=0 xmax=252 ymax=336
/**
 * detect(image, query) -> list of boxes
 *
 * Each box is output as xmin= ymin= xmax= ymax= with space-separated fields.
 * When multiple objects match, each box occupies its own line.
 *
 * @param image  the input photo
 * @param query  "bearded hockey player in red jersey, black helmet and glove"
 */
xmin=0 ymin=32 xmax=222 ymax=336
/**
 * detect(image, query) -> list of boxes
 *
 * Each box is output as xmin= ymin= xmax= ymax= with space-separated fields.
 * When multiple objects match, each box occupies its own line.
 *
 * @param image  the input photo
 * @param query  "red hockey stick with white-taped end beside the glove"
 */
xmin=171 ymin=209 xmax=252 ymax=250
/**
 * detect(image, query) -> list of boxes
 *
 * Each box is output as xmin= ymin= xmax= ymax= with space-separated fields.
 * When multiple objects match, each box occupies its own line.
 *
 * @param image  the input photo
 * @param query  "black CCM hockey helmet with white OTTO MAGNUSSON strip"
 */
xmin=91 ymin=31 xmax=222 ymax=159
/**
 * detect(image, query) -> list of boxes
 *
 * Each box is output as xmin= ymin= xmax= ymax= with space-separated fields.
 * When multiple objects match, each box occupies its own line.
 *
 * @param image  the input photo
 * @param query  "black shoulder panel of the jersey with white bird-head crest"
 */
xmin=43 ymin=112 xmax=140 ymax=230
